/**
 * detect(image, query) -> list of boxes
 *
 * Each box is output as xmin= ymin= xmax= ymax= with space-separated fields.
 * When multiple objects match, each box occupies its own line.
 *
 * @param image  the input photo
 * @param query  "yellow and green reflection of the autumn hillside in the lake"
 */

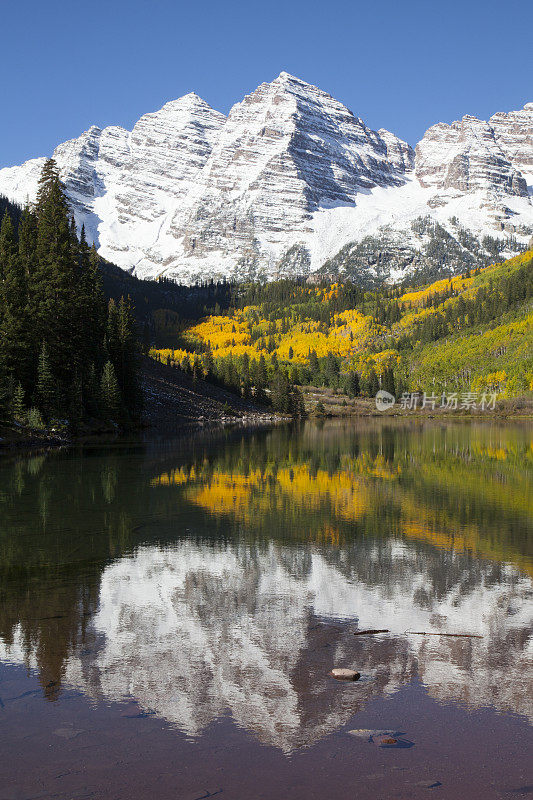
xmin=151 ymin=429 xmax=533 ymax=575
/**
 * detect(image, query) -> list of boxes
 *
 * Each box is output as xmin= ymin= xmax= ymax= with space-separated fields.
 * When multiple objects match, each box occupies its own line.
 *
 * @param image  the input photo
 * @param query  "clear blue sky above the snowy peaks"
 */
xmin=0 ymin=0 xmax=533 ymax=166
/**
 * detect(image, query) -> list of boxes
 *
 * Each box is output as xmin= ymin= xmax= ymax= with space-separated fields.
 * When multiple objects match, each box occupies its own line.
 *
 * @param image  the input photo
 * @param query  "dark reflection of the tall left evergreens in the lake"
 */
xmin=0 ymin=446 xmax=148 ymax=700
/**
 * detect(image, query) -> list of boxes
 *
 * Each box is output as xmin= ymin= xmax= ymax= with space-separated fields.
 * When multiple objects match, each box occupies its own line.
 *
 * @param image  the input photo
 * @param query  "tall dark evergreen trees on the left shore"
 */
xmin=0 ymin=159 xmax=141 ymax=428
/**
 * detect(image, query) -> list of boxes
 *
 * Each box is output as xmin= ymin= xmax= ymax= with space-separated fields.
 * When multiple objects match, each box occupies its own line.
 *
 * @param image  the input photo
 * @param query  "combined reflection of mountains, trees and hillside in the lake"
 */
xmin=0 ymin=420 xmax=533 ymax=750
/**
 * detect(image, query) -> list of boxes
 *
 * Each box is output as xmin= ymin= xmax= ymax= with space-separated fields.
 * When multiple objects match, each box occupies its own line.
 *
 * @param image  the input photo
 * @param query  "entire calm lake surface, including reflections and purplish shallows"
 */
xmin=0 ymin=421 xmax=533 ymax=800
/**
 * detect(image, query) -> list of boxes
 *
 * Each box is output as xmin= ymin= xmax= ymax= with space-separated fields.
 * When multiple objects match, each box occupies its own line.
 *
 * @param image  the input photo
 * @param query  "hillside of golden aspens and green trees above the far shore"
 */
xmin=152 ymin=250 xmax=533 ymax=398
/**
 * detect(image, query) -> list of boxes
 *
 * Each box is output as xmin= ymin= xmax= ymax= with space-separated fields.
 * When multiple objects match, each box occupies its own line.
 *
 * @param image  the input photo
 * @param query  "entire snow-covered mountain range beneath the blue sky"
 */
xmin=0 ymin=72 xmax=533 ymax=281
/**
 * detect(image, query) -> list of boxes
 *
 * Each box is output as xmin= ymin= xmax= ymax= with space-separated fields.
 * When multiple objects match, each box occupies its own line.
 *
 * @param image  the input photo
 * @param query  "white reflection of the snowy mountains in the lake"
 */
xmin=0 ymin=540 xmax=533 ymax=750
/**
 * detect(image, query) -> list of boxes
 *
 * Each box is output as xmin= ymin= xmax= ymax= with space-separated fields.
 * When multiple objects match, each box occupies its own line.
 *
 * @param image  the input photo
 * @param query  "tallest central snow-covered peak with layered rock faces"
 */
xmin=164 ymin=73 xmax=412 ymax=280
